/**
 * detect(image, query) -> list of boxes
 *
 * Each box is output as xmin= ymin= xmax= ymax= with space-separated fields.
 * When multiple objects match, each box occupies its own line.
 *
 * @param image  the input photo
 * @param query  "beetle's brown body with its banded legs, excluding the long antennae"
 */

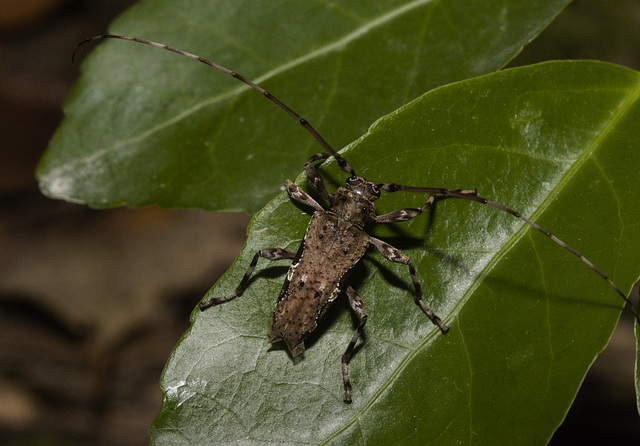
xmin=200 ymin=159 xmax=475 ymax=404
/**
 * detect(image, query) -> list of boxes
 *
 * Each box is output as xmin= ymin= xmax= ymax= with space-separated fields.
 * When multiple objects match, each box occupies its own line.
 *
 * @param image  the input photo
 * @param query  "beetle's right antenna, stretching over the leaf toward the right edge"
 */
xmin=378 ymin=183 xmax=640 ymax=324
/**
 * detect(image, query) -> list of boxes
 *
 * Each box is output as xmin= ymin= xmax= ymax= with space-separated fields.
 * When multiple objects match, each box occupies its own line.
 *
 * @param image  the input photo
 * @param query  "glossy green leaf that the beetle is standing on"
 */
xmin=151 ymin=62 xmax=640 ymax=445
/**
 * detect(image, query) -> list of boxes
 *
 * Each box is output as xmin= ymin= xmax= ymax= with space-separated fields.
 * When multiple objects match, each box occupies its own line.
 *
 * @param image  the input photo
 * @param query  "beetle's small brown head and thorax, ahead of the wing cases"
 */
xmin=329 ymin=175 xmax=380 ymax=228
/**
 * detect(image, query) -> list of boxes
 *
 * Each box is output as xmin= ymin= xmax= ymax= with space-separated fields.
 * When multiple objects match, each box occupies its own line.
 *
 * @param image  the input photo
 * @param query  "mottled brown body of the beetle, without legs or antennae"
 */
xmin=270 ymin=179 xmax=379 ymax=356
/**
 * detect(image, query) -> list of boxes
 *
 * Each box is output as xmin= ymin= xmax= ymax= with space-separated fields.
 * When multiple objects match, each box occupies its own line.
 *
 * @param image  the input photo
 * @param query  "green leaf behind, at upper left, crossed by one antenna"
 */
xmin=38 ymin=0 xmax=569 ymax=213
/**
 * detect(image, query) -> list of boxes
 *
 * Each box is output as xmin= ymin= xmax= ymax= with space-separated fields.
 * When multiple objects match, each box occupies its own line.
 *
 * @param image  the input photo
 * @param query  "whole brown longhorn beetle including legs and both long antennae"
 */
xmin=74 ymin=34 xmax=640 ymax=403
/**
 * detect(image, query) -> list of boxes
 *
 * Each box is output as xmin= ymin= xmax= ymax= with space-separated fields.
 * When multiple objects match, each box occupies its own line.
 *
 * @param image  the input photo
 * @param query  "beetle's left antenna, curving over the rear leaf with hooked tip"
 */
xmin=71 ymin=34 xmax=355 ymax=176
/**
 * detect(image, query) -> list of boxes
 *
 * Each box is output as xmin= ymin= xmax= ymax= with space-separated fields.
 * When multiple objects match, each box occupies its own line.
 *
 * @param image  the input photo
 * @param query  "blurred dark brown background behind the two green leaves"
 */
xmin=0 ymin=0 xmax=640 ymax=445
